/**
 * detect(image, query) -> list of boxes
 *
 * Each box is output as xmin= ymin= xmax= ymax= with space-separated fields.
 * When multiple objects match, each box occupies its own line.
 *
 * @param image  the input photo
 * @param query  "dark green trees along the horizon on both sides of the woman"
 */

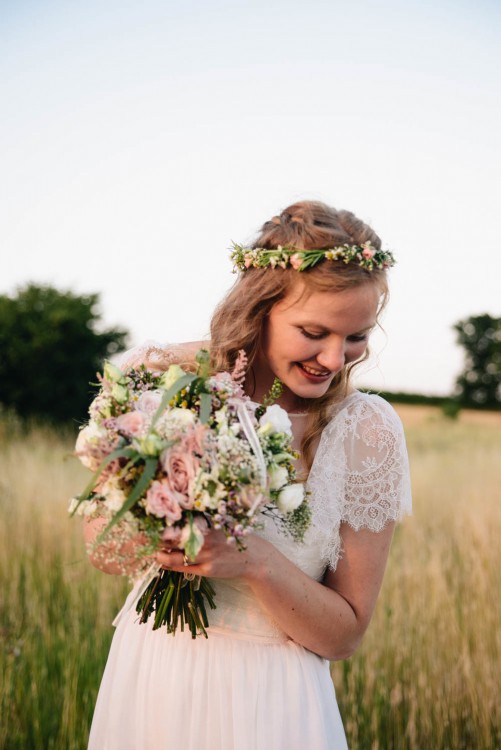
xmin=0 ymin=284 xmax=501 ymax=423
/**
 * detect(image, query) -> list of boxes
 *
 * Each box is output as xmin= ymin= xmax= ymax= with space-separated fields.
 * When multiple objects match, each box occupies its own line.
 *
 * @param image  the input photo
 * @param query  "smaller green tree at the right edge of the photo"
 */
xmin=454 ymin=314 xmax=501 ymax=409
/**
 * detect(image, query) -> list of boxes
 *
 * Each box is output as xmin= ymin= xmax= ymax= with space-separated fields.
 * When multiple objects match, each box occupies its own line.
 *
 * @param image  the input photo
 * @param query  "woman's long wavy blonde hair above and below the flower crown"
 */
xmin=210 ymin=201 xmax=388 ymax=470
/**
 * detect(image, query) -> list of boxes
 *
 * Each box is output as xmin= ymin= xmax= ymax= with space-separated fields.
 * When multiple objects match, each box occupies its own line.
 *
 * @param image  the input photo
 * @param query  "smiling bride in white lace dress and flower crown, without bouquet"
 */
xmin=87 ymin=202 xmax=410 ymax=750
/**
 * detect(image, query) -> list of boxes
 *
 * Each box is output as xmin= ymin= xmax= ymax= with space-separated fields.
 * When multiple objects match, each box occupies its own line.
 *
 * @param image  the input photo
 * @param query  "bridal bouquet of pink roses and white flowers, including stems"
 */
xmin=70 ymin=350 xmax=310 ymax=638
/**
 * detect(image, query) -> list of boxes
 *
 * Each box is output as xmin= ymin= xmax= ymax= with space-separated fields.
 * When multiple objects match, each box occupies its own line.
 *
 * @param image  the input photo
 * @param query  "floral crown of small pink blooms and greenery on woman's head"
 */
xmin=230 ymin=241 xmax=396 ymax=273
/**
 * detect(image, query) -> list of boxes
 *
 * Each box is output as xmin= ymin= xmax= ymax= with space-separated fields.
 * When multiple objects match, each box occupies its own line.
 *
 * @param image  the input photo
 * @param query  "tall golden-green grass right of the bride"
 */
xmin=333 ymin=407 xmax=501 ymax=750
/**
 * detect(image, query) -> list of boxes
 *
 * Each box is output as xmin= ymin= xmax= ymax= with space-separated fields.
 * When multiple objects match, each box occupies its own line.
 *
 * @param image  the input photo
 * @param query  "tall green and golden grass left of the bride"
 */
xmin=0 ymin=421 xmax=126 ymax=750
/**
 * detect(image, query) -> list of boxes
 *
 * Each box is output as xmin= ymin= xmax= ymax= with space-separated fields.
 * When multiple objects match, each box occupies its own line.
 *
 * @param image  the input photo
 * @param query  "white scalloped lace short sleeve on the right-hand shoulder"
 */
xmin=308 ymin=393 xmax=412 ymax=568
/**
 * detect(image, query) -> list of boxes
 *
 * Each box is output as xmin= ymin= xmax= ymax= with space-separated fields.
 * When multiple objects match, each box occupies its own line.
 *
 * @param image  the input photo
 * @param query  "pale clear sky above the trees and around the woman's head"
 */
xmin=0 ymin=0 xmax=501 ymax=394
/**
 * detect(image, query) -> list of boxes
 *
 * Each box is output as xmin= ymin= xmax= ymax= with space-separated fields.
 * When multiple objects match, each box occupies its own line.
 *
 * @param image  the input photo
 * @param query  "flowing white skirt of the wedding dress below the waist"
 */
xmin=89 ymin=609 xmax=347 ymax=750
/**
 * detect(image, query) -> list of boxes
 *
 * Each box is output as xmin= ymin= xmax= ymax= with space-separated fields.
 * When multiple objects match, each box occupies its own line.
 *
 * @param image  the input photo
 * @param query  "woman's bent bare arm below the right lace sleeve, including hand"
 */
xmin=157 ymin=523 xmax=394 ymax=660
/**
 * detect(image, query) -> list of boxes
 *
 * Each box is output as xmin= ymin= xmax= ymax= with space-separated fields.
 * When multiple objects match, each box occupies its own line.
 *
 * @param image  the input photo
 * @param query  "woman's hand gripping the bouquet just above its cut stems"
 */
xmin=156 ymin=529 xmax=274 ymax=581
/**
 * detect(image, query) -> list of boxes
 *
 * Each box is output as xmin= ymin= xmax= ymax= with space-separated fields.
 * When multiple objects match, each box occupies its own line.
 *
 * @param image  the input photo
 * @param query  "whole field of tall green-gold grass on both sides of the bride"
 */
xmin=0 ymin=406 xmax=501 ymax=750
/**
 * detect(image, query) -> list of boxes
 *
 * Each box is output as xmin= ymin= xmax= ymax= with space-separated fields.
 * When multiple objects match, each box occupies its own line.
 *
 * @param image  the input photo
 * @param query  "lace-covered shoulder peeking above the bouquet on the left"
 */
xmin=116 ymin=339 xmax=209 ymax=370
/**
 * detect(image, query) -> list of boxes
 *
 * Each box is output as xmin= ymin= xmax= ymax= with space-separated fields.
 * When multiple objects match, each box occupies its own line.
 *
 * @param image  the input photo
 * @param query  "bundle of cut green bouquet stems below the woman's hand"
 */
xmin=136 ymin=570 xmax=216 ymax=638
